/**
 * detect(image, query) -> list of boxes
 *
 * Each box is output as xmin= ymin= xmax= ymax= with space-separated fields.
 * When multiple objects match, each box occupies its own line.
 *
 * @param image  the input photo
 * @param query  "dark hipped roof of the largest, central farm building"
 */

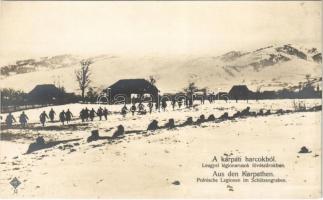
xmin=108 ymin=79 xmax=158 ymax=93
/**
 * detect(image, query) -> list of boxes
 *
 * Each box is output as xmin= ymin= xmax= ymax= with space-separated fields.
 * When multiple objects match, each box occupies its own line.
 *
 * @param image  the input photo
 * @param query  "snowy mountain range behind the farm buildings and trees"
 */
xmin=0 ymin=44 xmax=322 ymax=92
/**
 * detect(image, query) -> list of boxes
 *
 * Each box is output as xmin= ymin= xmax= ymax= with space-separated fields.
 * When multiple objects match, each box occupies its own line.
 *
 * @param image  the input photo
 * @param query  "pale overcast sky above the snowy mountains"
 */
xmin=0 ymin=1 xmax=321 ymax=61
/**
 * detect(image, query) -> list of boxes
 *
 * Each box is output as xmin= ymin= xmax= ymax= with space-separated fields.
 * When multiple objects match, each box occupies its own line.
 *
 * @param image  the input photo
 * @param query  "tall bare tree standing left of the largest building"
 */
xmin=75 ymin=60 xmax=92 ymax=101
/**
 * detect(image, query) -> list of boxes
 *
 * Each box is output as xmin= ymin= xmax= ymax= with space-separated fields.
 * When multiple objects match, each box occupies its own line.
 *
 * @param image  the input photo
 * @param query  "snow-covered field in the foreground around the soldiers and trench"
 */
xmin=0 ymin=100 xmax=321 ymax=198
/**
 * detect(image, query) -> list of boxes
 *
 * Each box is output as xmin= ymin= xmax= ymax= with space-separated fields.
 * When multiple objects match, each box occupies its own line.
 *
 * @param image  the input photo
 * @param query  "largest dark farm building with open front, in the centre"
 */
xmin=104 ymin=79 xmax=159 ymax=103
